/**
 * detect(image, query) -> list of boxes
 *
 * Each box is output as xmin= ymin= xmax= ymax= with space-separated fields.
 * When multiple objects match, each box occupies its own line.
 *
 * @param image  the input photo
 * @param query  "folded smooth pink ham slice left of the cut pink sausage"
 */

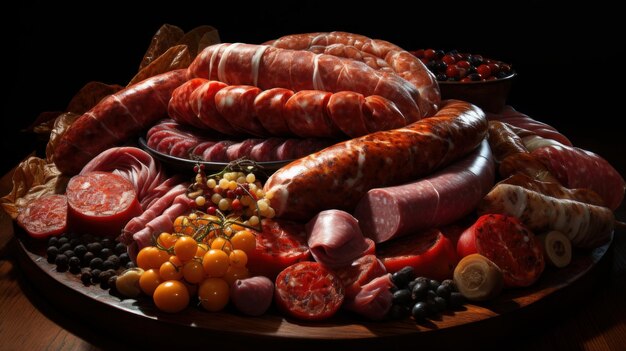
xmin=306 ymin=210 xmax=374 ymax=268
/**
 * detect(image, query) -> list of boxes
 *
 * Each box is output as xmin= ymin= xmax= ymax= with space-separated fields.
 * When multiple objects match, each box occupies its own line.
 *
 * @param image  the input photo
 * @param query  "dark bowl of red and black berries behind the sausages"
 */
xmin=411 ymin=49 xmax=516 ymax=112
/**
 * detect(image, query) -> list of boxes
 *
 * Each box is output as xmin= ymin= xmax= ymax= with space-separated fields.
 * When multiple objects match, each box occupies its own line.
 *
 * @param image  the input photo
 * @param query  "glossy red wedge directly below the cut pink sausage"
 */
xmin=377 ymin=229 xmax=458 ymax=280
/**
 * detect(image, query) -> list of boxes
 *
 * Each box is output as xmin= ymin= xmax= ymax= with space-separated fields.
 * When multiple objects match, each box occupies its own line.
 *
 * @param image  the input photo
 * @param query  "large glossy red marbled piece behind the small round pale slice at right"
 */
xmin=468 ymin=214 xmax=545 ymax=287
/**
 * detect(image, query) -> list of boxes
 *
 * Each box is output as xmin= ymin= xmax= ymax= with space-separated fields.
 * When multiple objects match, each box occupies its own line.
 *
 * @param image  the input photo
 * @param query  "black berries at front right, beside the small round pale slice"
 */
xmin=389 ymin=266 xmax=464 ymax=321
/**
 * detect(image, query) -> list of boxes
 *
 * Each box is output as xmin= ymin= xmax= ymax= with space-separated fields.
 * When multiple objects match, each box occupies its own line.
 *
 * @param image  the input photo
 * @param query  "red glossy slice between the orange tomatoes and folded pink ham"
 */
xmin=248 ymin=219 xmax=311 ymax=280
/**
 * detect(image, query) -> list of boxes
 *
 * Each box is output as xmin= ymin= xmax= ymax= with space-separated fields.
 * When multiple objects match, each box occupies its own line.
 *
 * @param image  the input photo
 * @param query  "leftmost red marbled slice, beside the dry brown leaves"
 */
xmin=17 ymin=195 xmax=67 ymax=238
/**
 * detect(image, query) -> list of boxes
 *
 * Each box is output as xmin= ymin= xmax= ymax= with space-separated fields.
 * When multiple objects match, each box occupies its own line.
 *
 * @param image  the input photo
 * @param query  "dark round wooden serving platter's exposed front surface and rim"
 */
xmin=9 ymin=217 xmax=610 ymax=350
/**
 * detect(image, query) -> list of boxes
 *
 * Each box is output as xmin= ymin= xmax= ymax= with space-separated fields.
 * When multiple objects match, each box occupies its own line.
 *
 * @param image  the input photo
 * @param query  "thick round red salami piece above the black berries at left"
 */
xmin=67 ymin=172 xmax=142 ymax=236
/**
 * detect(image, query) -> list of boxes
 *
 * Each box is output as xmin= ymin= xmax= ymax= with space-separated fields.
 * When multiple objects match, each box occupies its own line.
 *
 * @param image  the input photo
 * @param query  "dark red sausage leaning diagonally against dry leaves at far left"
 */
xmin=54 ymin=70 xmax=187 ymax=174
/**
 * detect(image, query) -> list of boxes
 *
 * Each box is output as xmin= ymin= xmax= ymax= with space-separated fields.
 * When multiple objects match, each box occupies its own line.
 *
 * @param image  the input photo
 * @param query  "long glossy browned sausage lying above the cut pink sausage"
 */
xmin=264 ymin=100 xmax=487 ymax=219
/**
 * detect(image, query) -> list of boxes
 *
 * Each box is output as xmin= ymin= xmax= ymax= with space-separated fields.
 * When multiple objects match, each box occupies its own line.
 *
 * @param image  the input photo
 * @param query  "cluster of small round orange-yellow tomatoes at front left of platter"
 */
xmin=117 ymin=212 xmax=256 ymax=313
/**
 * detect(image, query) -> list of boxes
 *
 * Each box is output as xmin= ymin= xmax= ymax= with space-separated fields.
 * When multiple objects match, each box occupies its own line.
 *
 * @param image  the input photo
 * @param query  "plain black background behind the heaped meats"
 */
xmin=1 ymin=1 xmax=626 ymax=174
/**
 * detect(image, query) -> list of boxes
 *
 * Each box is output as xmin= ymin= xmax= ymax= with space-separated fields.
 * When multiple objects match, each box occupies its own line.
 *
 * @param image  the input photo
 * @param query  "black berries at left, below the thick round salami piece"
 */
xmin=46 ymin=233 xmax=134 ymax=289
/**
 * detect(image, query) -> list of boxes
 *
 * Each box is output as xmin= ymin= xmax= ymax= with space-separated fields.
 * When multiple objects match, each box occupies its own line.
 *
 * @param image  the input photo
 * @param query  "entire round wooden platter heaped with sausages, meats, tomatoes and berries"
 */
xmin=0 ymin=25 xmax=626 ymax=349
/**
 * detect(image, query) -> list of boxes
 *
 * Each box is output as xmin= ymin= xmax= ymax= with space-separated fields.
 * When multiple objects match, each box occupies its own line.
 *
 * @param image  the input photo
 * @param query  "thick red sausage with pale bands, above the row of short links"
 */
xmin=188 ymin=43 xmax=426 ymax=124
